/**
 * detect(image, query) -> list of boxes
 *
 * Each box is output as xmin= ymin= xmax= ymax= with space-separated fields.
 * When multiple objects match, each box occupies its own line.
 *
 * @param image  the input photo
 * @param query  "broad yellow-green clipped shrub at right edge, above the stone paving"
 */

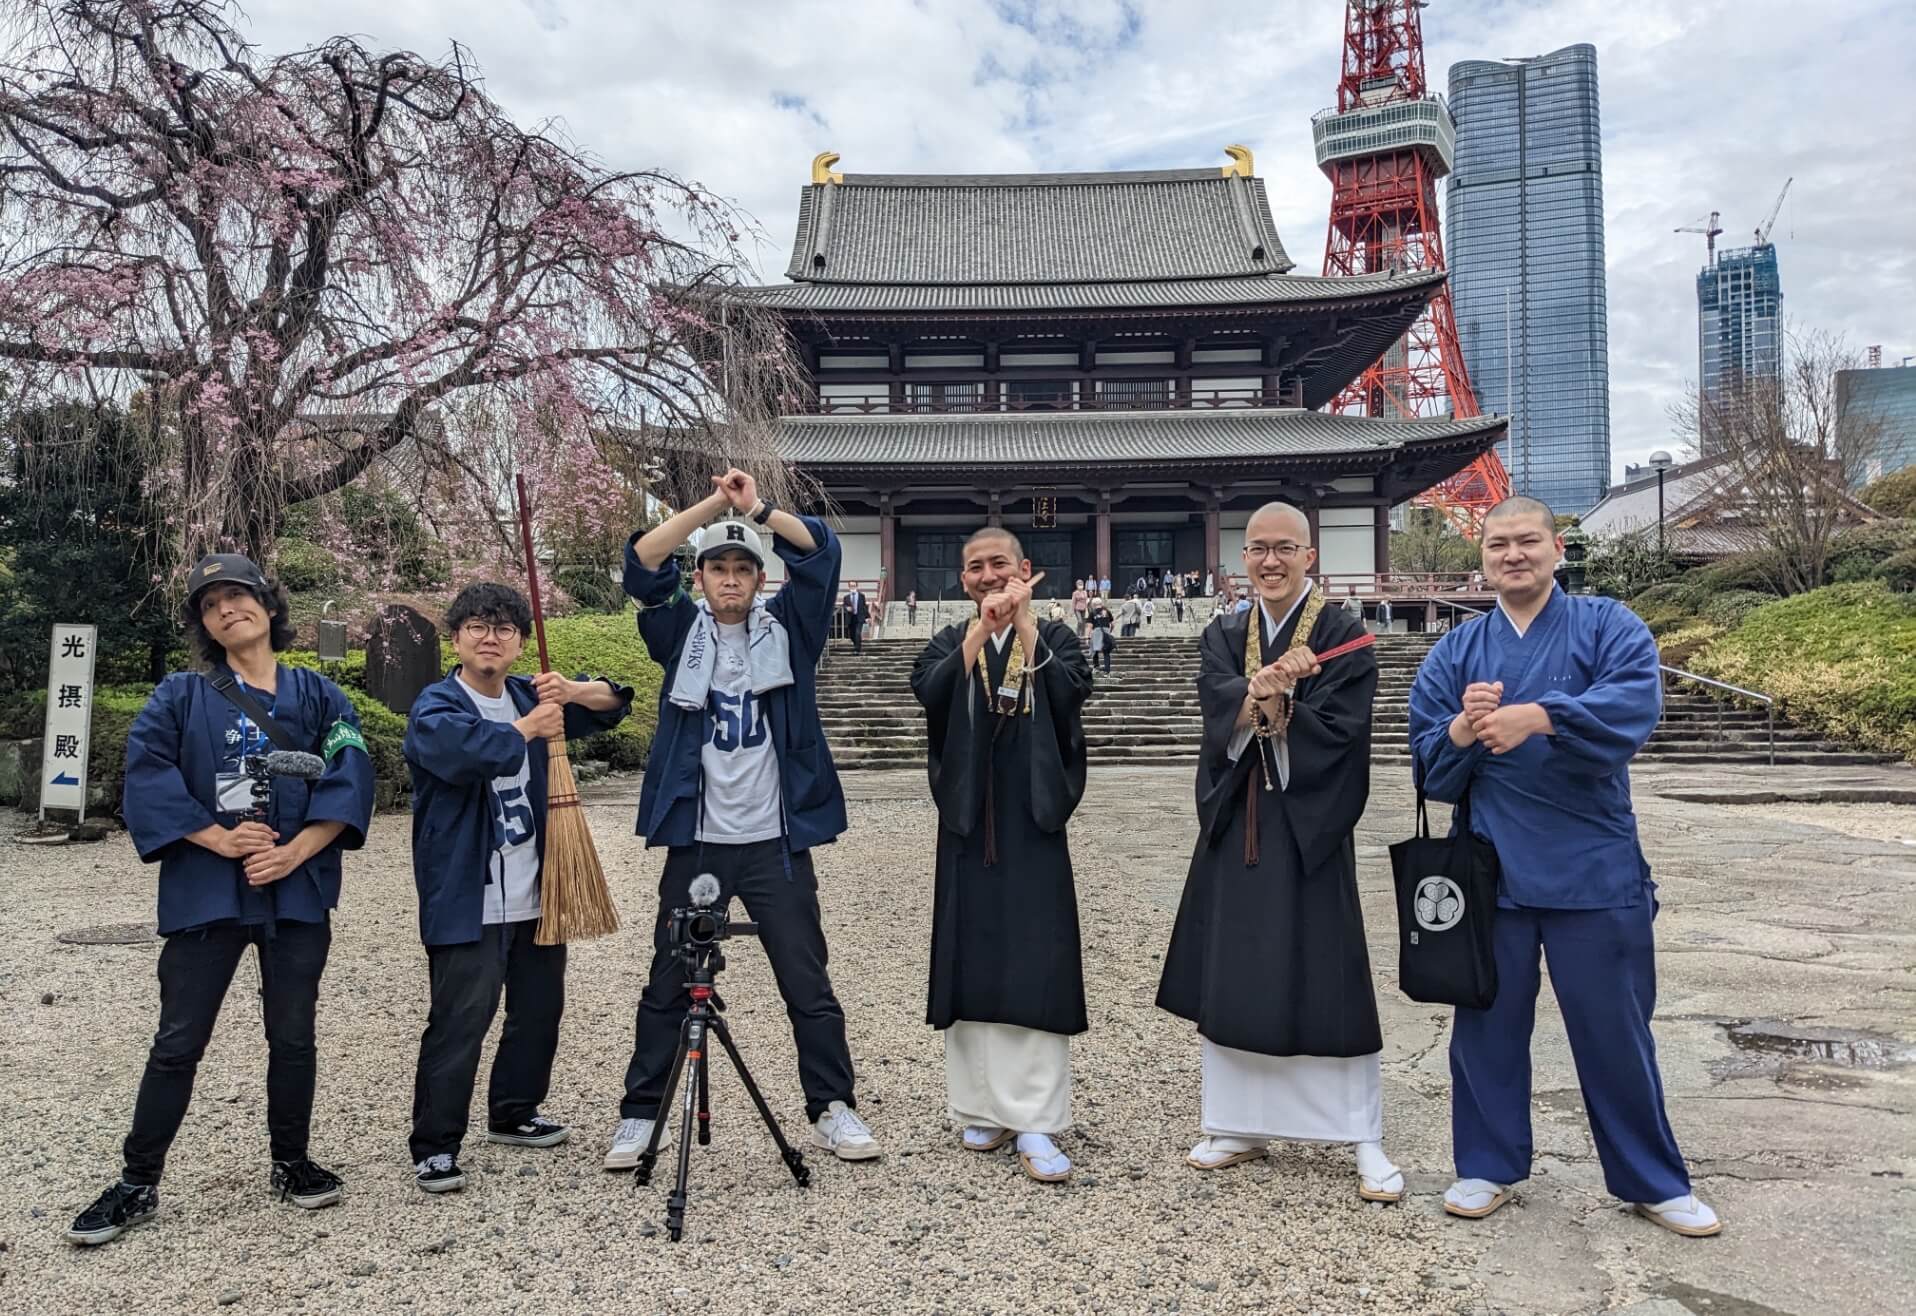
xmin=1692 ymin=580 xmax=1916 ymax=757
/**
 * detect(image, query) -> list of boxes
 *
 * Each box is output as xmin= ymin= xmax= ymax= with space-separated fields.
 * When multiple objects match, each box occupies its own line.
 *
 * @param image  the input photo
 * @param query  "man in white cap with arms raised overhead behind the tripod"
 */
xmin=605 ymin=469 xmax=878 ymax=1170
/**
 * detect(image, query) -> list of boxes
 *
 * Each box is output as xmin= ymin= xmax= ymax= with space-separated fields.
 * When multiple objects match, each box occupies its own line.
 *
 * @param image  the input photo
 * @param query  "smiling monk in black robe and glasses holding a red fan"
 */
xmin=1157 ymin=504 xmax=1403 ymax=1201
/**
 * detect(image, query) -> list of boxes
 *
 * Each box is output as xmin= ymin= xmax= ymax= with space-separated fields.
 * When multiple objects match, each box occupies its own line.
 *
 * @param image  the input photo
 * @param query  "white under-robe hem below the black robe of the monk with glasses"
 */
xmin=1201 ymin=1038 xmax=1383 ymax=1142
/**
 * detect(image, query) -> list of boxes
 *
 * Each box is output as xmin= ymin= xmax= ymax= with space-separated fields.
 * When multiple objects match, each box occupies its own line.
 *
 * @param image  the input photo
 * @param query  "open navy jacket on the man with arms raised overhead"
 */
xmin=625 ymin=517 xmax=845 ymax=851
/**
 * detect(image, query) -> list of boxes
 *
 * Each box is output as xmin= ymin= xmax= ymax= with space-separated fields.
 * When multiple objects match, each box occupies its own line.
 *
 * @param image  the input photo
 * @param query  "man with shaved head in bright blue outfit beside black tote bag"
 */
xmin=1410 ymin=498 xmax=1722 ymax=1237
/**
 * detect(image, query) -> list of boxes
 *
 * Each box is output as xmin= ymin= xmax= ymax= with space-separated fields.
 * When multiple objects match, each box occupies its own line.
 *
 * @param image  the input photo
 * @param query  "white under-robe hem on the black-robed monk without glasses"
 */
xmin=945 ymin=1019 xmax=1071 ymax=1134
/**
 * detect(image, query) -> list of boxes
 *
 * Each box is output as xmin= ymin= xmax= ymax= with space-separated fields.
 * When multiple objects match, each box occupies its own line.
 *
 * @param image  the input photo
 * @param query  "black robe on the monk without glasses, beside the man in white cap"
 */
xmin=912 ymin=621 xmax=1090 ymax=1034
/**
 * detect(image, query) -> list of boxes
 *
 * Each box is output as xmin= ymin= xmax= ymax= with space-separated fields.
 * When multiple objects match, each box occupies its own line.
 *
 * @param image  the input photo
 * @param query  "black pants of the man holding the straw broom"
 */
xmin=410 ymin=919 xmax=565 ymax=1165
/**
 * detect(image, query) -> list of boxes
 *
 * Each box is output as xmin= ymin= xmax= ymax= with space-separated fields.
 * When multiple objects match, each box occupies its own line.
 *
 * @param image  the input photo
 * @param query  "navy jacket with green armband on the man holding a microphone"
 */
xmin=123 ymin=667 xmax=374 ymax=935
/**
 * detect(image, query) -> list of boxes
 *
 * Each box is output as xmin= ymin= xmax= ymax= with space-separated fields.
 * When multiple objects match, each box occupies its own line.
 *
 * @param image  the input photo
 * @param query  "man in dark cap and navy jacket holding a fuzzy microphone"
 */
xmin=67 ymin=554 xmax=374 ymax=1243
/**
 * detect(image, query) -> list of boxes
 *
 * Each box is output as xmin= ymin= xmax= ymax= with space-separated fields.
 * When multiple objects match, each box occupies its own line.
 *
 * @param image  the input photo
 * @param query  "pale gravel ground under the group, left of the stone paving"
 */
xmin=0 ymin=772 xmax=1500 ymax=1314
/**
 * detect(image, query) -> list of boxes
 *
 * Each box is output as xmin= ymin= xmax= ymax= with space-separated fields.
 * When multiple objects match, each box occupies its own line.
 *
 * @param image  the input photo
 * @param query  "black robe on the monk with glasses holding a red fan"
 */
xmin=1157 ymin=605 xmax=1383 ymax=1055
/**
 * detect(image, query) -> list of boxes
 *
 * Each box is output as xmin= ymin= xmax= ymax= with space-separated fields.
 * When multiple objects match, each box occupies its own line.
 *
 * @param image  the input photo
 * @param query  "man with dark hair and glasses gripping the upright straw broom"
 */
xmin=406 ymin=582 xmax=632 ymax=1193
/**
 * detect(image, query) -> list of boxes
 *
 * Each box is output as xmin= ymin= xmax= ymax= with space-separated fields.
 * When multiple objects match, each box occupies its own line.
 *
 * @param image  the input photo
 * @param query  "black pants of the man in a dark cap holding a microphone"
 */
xmin=123 ymin=923 xmax=333 ymax=1184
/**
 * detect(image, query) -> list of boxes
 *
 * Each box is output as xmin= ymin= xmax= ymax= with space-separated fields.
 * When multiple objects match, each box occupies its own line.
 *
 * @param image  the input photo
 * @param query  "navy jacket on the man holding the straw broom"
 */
xmin=406 ymin=667 xmax=632 ymax=946
